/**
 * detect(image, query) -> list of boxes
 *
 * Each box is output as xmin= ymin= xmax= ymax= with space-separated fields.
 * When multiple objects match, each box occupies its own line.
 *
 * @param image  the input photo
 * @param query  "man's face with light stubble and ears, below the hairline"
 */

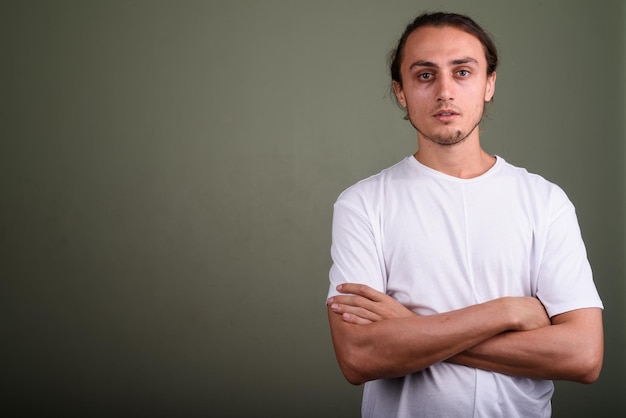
xmin=394 ymin=26 xmax=496 ymax=146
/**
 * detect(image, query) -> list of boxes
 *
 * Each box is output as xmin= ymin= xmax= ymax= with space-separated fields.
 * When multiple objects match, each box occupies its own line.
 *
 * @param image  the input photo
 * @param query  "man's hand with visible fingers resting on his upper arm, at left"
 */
xmin=327 ymin=283 xmax=416 ymax=325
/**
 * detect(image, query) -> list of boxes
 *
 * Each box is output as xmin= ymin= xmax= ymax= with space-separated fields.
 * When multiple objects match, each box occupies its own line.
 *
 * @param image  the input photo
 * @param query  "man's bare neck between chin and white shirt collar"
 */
xmin=414 ymin=138 xmax=496 ymax=179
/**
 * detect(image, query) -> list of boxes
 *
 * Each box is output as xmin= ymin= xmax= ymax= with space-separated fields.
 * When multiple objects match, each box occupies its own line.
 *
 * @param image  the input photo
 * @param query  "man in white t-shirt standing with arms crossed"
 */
xmin=328 ymin=13 xmax=603 ymax=417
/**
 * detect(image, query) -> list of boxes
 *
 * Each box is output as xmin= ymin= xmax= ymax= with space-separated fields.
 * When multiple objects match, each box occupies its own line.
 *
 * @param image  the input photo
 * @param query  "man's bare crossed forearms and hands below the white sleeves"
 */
xmin=328 ymin=283 xmax=604 ymax=384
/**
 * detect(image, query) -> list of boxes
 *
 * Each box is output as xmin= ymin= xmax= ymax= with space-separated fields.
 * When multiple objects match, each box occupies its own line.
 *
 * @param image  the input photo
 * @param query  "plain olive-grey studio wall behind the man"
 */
xmin=0 ymin=0 xmax=626 ymax=417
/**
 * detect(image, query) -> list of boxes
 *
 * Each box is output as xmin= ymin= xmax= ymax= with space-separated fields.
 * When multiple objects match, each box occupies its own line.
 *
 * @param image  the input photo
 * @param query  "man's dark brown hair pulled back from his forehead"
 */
xmin=389 ymin=12 xmax=498 ymax=86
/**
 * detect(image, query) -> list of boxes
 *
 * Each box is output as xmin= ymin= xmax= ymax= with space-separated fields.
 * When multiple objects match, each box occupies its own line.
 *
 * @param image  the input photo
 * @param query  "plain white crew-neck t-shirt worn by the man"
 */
xmin=328 ymin=156 xmax=602 ymax=418
